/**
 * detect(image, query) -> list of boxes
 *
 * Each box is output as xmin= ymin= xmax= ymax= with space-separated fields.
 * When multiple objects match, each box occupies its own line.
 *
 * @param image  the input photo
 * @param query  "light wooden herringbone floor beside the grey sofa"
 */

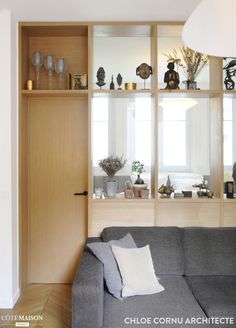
xmin=0 ymin=284 xmax=71 ymax=328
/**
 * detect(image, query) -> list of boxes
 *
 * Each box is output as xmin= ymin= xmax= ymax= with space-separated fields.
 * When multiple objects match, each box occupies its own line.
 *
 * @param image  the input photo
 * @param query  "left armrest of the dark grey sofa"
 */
xmin=72 ymin=238 xmax=104 ymax=328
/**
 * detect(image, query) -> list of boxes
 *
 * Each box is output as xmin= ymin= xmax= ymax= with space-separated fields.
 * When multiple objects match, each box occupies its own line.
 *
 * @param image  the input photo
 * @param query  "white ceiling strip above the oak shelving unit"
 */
xmin=0 ymin=0 xmax=200 ymax=21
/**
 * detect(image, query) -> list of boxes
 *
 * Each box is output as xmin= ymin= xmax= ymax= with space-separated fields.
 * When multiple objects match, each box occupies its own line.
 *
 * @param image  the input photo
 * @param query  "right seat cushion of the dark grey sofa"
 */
xmin=186 ymin=276 xmax=236 ymax=320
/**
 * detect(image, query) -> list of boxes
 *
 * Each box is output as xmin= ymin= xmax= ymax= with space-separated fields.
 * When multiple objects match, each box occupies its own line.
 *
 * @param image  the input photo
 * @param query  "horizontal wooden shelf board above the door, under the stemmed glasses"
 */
xmin=21 ymin=90 xmax=88 ymax=97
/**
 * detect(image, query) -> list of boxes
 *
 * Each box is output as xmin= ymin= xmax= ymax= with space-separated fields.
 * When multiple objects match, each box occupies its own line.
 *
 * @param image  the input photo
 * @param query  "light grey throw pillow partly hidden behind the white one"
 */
xmin=87 ymin=233 xmax=137 ymax=300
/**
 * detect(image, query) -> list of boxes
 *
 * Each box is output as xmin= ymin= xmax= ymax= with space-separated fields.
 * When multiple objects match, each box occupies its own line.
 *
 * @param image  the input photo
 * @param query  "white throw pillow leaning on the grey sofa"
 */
xmin=111 ymin=245 xmax=165 ymax=297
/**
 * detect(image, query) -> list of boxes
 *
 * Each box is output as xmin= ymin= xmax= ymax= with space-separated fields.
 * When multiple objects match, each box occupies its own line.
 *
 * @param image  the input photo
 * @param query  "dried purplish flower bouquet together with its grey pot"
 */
xmin=98 ymin=155 xmax=126 ymax=197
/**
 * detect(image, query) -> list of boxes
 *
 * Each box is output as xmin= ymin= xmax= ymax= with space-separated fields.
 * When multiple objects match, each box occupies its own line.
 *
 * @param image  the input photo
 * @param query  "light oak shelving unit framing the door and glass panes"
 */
xmin=19 ymin=22 xmax=236 ymax=274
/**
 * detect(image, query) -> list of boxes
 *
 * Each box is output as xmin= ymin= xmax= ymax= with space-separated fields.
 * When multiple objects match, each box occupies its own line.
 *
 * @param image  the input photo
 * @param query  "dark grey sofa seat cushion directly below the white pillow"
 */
xmin=103 ymin=275 xmax=208 ymax=328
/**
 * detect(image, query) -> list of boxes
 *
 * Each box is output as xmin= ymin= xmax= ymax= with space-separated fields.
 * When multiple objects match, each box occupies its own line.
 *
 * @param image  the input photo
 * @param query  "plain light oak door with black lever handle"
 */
xmin=28 ymin=97 xmax=88 ymax=283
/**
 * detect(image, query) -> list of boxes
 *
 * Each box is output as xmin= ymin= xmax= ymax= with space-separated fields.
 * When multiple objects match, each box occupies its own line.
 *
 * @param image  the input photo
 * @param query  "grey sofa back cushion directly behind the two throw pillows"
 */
xmin=102 ymin=227 xmax=184 ymax=275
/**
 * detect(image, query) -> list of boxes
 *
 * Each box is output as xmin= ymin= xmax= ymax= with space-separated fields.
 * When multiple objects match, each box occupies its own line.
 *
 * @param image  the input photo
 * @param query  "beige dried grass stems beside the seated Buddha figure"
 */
xmin=163 ymin=46 xmax=209 ymax=82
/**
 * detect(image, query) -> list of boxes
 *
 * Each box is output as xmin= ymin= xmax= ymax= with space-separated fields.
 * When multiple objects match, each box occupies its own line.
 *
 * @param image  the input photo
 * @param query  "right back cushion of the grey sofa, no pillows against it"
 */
xmin=183 ymin=228 xmax=236 ymax=276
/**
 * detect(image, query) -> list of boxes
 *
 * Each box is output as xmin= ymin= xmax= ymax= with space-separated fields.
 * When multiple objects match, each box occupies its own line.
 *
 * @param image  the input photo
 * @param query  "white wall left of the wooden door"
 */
xmin=0 ymin=10 xmax=19 ymax=308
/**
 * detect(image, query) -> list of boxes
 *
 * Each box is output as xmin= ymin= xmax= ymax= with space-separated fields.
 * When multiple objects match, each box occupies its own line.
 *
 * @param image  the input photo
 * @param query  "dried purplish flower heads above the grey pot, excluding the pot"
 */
xmin=98 ymin=155 xmax=126 ymax=181
